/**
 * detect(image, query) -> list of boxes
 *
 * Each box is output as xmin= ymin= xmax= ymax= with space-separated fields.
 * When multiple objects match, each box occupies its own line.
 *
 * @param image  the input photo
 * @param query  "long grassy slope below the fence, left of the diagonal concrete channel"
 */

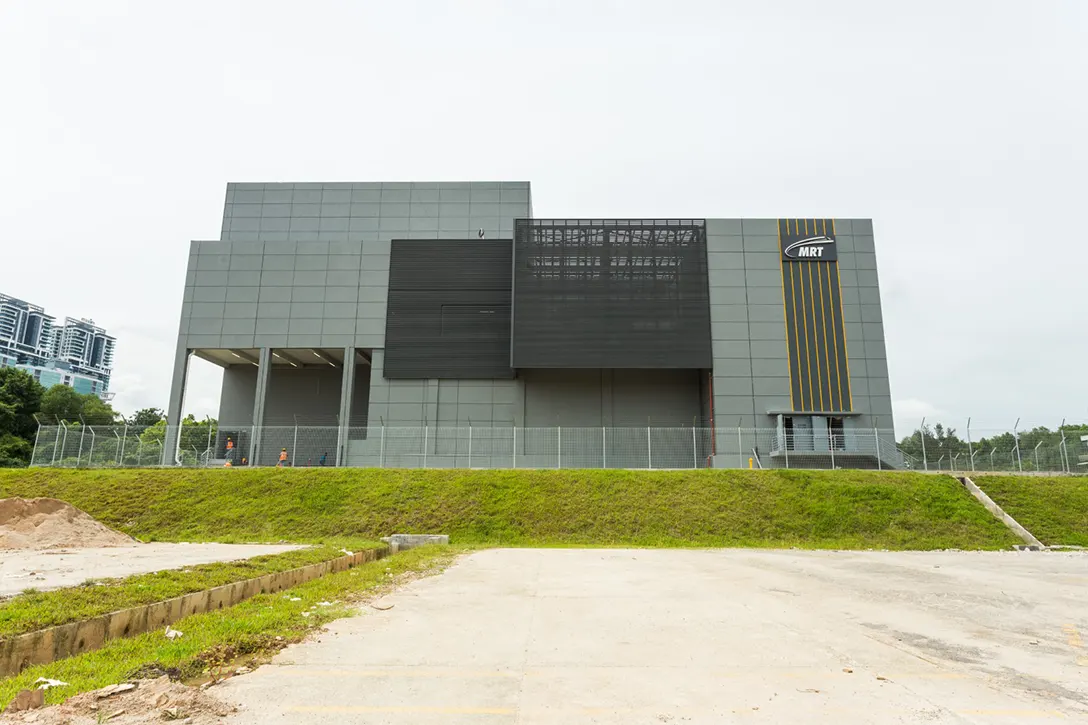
xmin=0 ymin=468 xmax=1019 ymax=550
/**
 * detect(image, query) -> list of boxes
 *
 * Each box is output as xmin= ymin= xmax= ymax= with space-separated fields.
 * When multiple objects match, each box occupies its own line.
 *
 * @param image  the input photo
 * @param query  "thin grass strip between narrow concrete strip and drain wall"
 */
xmin=0 ymin=542 xmax=376 ymax=639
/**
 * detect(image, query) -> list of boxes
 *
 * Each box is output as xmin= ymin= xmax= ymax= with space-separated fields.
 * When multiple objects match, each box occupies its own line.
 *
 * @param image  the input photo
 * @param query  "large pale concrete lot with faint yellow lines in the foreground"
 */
xmin=217 ymin=550 xmax=1088 ymax=725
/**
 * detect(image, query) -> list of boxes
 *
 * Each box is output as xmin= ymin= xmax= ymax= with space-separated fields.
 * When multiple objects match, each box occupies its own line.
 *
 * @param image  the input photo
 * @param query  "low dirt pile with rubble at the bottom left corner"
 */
xmin=3 ymin=676 xmax=235 ymax=725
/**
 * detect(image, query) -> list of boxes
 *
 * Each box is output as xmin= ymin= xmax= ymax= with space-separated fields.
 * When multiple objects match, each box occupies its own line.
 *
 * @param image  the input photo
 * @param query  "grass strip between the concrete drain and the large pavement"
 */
xmin=0 ymin=546 xmax=458 ymax=704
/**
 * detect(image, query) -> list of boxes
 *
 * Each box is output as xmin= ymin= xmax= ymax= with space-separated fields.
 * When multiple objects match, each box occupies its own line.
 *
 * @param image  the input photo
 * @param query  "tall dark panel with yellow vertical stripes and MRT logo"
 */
xmin=778 ymin=219 xmax=853 ymax=413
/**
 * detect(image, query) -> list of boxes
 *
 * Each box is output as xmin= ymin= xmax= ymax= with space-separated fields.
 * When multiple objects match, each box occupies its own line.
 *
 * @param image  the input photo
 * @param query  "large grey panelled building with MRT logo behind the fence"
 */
xmin=166 ymin=182 xmax=894 ymax=467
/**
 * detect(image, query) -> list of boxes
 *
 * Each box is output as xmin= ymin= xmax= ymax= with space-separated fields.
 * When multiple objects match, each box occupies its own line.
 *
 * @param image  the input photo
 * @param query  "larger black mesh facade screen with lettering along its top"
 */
xmin=511 ymin=219 xmax=713 ymax=368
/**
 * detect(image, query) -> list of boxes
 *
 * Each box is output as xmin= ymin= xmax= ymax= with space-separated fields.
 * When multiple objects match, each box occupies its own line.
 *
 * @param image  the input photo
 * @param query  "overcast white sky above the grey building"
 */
xmin=0 ymin=0 xmax=1088 ymax=434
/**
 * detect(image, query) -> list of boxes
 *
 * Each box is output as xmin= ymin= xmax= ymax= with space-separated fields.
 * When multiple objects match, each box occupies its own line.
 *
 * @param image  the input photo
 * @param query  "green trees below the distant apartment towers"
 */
xmin=0 ymin=368 xmax=219 ymax=468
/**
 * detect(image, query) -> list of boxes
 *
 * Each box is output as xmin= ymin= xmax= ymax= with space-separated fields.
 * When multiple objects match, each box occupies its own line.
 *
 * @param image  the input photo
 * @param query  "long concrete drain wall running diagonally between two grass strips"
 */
xmin=0 ymin=546 xmax=391 ymax=677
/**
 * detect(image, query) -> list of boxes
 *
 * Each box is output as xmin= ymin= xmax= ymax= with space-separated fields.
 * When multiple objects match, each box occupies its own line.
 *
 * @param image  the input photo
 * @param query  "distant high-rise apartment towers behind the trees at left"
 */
xmin=0 ymin=294 xmax=116 ymax=396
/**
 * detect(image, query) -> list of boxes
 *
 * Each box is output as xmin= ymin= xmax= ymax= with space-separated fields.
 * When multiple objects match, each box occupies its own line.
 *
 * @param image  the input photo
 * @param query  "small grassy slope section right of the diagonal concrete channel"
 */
xmin=972 ymin=476 xmax=1088 ymax=546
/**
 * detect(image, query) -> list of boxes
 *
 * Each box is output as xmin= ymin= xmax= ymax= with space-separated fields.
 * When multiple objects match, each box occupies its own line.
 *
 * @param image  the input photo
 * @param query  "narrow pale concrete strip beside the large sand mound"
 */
xmin=0 ymin=543 xmax=301 ymax=597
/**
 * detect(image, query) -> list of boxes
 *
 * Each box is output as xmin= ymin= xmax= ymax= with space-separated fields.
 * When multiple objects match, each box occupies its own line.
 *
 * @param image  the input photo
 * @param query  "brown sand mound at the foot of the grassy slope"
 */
xmin=0 ymin=499 xmax=137 ymax=549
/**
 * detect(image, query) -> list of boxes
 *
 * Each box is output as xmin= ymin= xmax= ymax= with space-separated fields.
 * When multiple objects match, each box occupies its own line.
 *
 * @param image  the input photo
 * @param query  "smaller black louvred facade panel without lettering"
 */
xmin=384 ymin=239 xmax=514 ymax=380
